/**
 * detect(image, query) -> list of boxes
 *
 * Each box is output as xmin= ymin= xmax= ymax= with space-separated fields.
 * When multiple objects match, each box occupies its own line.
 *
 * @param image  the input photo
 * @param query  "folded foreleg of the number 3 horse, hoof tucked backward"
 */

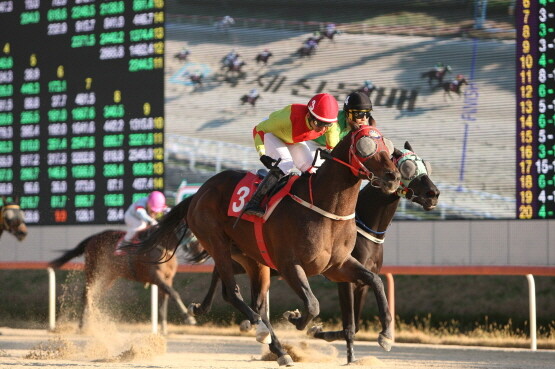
xmin=280 ymin=264 xmax=320 ymax=330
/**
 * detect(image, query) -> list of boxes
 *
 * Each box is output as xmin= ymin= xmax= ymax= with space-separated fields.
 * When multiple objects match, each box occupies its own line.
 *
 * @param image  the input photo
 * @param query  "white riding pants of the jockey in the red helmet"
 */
xmin=264 ymin=133 xmax=313 ymax=174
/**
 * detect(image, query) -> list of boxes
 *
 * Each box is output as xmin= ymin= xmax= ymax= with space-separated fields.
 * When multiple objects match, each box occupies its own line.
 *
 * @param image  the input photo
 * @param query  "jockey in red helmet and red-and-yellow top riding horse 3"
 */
xmin=245 ymin=93 xmax=339 ymax=217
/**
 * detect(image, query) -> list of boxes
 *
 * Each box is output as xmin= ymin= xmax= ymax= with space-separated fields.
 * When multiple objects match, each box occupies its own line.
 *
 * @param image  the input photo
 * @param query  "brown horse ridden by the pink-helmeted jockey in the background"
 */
xmin=49 ymin=228 xmax=200 ymax=334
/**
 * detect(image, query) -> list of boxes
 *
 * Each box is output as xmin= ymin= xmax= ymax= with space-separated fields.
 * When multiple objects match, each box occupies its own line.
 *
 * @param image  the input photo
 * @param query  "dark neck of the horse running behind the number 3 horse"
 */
xmin=356 ymin=184 xmax=401 ymax=232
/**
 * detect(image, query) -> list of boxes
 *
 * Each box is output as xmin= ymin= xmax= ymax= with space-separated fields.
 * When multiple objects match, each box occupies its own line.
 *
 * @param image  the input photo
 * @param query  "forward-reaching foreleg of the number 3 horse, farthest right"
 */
xmin=324 ymin=256 xmax=393 ymax=351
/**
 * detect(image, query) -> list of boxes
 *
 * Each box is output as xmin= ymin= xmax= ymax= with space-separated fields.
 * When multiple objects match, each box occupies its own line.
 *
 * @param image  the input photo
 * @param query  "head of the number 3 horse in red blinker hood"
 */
xmin=349 ymin=126 xmax=401 ymax=194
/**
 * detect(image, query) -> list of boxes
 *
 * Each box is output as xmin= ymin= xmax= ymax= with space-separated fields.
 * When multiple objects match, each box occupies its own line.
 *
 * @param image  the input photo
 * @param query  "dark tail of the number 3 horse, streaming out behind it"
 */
xmin=131 ymin=196 xmax=193 ymax=254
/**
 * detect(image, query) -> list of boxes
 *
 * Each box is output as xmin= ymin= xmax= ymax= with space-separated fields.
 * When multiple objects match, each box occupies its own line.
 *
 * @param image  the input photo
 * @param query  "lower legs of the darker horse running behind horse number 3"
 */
xmin=309 ymin=282 xmax=355 ymax=364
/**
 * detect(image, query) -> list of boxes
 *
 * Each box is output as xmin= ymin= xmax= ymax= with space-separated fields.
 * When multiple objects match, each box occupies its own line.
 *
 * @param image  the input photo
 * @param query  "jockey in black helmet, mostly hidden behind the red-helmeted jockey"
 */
xmin=307 ymin=91 xmax=376 ymax=167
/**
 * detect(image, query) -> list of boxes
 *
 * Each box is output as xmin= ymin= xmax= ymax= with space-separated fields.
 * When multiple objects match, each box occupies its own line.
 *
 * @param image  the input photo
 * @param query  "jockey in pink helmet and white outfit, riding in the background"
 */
xmin=115 ymin=191 xmax=169 ymax=255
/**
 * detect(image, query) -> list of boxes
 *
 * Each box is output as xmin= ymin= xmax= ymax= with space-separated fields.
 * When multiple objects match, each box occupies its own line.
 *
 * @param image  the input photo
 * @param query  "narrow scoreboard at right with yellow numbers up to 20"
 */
xmin=515 ymin=0 xmax=555 ymax=219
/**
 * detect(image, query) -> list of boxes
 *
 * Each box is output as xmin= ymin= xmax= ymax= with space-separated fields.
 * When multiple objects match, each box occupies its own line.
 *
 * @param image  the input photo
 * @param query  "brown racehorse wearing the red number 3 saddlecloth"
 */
xmin=138 ymin=126 xmax=400 ymax=365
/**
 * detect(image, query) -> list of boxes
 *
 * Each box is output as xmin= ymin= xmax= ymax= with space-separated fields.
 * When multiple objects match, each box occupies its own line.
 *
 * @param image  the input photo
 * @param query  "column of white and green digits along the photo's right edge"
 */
xmin=535 ymin=0 xmax=555 ymax=218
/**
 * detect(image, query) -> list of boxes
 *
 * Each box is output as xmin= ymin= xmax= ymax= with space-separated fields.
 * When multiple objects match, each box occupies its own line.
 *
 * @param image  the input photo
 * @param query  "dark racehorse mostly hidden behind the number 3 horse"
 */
xmin=309 ymin=142 xmax=440 ymax=363
